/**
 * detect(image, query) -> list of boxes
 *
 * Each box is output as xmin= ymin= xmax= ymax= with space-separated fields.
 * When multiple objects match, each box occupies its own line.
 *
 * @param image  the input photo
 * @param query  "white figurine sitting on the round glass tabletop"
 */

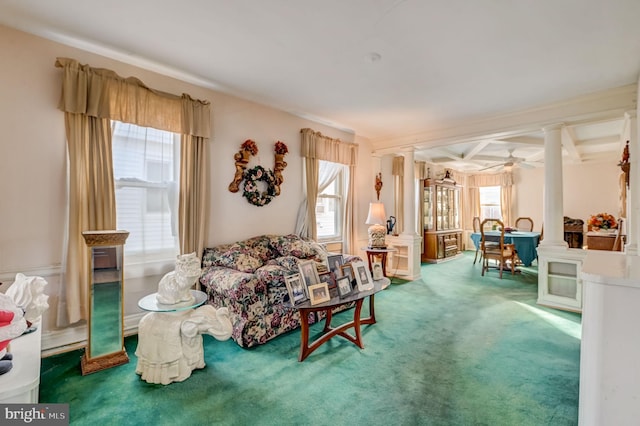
xmin=156 ymin=252 xmax=201 ymax=305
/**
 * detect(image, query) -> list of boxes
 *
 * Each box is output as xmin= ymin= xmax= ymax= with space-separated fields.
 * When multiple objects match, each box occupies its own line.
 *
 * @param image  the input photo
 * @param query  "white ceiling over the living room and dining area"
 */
xmin=0 ymin=0 xmax=640 ymax=170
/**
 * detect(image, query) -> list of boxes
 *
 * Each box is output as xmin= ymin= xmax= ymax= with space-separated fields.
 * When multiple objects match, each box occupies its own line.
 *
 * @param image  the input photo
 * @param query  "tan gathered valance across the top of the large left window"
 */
xmin=56 ymin=58 xmax=211 ymax=138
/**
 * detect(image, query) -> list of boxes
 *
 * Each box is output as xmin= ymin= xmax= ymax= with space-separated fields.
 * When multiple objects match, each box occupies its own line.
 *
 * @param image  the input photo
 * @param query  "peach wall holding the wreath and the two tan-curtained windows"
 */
xmin=0 ymin=26 xmax=374 ymax=342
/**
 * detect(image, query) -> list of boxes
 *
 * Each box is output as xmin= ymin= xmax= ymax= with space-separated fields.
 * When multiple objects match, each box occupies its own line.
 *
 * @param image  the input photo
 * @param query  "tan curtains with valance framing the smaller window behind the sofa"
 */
xmin=296 ymin=128 xmax=358 ymax=253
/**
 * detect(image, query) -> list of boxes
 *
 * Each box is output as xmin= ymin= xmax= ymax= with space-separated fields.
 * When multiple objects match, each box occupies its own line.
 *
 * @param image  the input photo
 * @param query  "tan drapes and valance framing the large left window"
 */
xmin=55 ymin=58 xmax=211 ymax=326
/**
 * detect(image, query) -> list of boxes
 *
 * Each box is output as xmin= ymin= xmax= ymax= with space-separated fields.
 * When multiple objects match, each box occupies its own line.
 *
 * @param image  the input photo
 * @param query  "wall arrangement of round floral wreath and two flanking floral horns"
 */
xmin=229 ymin=139 xmax=289 ymax=207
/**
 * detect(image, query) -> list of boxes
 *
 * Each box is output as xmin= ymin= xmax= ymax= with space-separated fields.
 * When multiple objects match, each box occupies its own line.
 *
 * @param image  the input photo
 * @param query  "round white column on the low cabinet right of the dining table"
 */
xmin=540 ymin=124 xmax=568 ymax=248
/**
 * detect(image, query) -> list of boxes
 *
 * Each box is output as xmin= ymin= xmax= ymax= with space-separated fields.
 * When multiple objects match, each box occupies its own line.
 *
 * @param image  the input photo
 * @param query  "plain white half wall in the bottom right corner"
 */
xmin=578 ymin=250 xmax=640 ymax=426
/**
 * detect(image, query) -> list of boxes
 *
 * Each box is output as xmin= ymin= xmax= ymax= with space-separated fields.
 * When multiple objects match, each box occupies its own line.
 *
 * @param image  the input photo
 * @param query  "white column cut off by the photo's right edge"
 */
xmin=624 ymin=111 xmax=640 ymax=256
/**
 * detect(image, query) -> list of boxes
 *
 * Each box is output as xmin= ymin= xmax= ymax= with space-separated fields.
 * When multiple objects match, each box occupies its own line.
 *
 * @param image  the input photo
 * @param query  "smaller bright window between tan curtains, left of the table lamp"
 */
xmin=316 ymin=161 xmax=346 ymax=241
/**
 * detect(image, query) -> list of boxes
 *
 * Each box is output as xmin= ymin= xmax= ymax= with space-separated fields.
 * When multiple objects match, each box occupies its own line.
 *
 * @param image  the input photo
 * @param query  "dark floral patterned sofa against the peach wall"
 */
xmin=200 ymin=234 xmax=360 ymax=348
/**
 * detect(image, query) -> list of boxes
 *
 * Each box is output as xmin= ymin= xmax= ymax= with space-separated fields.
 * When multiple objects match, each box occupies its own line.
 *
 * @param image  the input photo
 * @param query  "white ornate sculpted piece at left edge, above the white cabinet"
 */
xmin=5 ymin=273 xmax=49 ymax=324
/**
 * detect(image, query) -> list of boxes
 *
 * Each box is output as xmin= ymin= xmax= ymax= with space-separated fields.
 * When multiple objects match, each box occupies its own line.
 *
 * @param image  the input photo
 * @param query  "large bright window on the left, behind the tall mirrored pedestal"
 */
xmin=112 ymin=121 xmax=180 ymax=263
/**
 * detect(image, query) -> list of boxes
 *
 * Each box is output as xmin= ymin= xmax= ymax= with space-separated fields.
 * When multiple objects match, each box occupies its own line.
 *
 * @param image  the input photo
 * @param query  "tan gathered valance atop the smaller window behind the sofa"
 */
xmin=300 ymin=129 xmax=358 ymax=166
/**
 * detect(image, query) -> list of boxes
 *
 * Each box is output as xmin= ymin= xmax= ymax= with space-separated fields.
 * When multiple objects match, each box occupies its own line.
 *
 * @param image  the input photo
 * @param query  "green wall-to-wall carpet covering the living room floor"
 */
xmin=40 ymin=252 xmax=581 ymax=426
